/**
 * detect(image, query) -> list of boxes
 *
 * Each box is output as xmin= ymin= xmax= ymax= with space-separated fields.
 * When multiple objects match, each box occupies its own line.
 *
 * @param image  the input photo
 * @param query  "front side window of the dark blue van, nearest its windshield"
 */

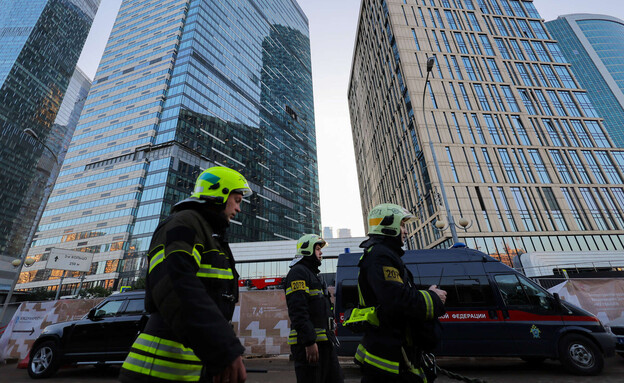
xmin=494 ymin=274 xmax=554 ymax=311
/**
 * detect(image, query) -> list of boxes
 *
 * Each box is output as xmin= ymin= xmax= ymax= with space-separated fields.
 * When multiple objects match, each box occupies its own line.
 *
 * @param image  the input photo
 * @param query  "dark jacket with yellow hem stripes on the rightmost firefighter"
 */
xmin=355 ymin=235 xmax=444 ymax=380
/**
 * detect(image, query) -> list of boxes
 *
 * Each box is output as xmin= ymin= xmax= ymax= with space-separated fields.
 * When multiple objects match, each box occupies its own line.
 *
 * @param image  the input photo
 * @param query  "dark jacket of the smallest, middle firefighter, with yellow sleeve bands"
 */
xmin=284 ymin=256 xmax=335 ymax=346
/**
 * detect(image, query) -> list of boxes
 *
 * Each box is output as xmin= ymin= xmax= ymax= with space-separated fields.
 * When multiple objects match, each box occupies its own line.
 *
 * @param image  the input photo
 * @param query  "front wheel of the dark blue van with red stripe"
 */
xmin=559 ymin=334 xmax=604 ymax=375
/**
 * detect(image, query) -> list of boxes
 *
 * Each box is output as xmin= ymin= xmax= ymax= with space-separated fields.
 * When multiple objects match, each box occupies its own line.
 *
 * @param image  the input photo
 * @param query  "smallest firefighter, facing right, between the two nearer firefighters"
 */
xmin=284 ymin=234 xmax=344 ymax=383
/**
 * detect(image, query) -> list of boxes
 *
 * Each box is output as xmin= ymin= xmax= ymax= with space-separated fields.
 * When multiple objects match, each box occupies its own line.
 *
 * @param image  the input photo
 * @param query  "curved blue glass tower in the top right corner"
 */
xmin=545 ymin=14 xmax=624 ymax=148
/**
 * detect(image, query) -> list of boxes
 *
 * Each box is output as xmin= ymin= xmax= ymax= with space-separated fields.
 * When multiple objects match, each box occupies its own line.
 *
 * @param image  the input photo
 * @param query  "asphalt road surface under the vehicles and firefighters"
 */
xmin=0 ymin=357 xmax=624 ymax=383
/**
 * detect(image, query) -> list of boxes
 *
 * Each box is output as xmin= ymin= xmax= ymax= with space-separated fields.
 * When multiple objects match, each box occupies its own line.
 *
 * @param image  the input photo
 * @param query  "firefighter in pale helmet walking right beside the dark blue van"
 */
xmin=354 ymin=203 xmax=446 ymax=383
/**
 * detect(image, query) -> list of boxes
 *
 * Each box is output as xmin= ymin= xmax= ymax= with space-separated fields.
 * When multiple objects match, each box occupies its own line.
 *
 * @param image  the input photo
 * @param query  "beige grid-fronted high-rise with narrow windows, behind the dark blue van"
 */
xmin=348 ymin=0 xmax=624 ymax=261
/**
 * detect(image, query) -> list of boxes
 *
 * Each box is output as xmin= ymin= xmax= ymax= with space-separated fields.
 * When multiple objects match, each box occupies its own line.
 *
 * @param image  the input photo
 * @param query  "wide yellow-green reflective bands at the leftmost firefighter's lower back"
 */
xmin=122 ymin=334 xmax=202 ymax=382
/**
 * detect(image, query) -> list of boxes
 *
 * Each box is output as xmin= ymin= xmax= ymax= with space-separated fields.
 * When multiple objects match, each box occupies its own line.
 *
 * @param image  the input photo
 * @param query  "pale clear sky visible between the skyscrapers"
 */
xmin=78 ymin=0 xmax=624 ymax=237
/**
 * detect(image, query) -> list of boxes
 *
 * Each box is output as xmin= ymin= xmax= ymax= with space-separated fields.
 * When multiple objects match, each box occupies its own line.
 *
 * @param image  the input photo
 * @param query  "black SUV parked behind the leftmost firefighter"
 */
xmin=28 ymin=291 xmax=148 ymax=379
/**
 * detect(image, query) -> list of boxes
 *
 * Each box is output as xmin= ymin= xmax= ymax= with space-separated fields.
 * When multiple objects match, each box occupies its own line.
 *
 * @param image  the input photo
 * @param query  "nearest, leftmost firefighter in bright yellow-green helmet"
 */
xmin=120 ymin=167 xmax=252 ymax=383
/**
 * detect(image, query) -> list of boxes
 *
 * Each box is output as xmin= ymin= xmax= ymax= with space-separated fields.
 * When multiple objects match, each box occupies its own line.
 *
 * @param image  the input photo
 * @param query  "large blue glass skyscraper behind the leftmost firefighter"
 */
xmin=18 ymin=0 xmax=321 ymax=289
